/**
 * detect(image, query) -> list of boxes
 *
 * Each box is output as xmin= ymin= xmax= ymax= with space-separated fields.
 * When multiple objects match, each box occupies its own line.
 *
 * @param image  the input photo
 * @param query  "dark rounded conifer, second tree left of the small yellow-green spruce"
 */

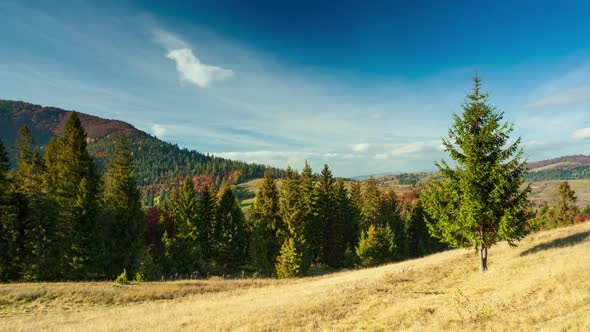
xmin=213 ymin=184 xmax=247 ymax=268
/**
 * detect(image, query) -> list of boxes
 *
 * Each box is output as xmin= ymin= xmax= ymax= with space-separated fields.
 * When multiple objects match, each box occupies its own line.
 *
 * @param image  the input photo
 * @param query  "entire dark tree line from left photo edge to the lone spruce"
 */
xmin=0 ymin=113 xmax=444 ymax=281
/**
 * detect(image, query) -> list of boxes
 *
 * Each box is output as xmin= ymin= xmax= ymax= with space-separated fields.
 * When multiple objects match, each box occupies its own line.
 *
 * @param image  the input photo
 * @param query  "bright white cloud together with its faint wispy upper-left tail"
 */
xmin=154 ymin=30 xmax=234 ymax=88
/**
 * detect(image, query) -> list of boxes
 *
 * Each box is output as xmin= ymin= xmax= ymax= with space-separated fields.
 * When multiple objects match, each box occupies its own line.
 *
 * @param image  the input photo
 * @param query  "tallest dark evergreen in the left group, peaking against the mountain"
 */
xmin=45 ymin=112 xmax=101 ymax=279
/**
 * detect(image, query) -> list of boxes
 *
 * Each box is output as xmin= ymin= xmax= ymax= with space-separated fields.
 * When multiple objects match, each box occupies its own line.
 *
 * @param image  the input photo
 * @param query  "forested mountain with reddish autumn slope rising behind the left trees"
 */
xmin=0 ymin=100 xmax=283 ymax=205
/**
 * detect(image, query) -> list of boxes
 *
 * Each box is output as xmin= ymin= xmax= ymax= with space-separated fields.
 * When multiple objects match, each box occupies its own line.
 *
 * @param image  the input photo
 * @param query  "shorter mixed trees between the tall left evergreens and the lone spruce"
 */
xmin=138 ymin=163 xmax=445 ymax=280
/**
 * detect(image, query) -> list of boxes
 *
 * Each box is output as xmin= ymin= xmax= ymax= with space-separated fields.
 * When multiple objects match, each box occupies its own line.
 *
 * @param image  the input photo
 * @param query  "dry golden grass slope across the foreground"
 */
xmin=0 ymin=223 xmax=590 ymax=331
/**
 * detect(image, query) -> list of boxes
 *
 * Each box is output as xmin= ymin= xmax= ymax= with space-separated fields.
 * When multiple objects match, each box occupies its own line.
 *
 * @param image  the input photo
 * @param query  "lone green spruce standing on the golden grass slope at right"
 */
xmin=424 ymin=75 xmax=530 ymax=272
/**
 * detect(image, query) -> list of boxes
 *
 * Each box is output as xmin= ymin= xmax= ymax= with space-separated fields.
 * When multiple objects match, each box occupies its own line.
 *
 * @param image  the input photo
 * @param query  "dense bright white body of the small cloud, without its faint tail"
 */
xmin=166 ymin=48 xmax=233 ymax=88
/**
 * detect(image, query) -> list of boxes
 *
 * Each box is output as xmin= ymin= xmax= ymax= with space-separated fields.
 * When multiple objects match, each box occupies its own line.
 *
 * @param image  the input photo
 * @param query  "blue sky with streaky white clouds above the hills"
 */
xmin=0 ymin=0 xmax=590 ymax=176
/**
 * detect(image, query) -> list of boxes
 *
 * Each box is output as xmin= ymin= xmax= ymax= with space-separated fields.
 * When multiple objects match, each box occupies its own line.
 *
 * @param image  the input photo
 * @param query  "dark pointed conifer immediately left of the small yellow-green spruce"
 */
xmin=249 ymin=171 xmax=285 ymax=274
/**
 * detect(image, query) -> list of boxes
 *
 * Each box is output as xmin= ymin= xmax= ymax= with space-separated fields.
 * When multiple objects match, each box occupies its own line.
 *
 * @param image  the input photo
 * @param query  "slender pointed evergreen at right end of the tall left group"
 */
xmin=104 ymin=135 xmax=145 ymax=278
